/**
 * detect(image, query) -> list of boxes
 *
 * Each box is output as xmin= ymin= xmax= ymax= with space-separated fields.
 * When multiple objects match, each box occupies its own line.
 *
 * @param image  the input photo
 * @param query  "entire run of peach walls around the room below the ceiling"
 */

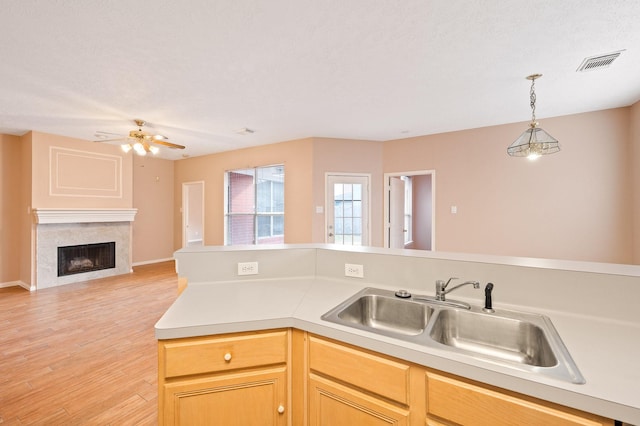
xmin=0 ymin=103 xmax=640 ymax=285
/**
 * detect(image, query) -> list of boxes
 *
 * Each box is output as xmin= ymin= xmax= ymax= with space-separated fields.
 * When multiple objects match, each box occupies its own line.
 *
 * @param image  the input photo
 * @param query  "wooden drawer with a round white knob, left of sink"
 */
xmin=160 ymin=330 xmax=288 ymax=378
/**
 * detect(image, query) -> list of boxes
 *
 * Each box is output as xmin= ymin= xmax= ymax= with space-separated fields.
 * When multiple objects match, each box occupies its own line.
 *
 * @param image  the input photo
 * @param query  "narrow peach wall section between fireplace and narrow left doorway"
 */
xmin=132 ymin=155 xmax=174 ymax=264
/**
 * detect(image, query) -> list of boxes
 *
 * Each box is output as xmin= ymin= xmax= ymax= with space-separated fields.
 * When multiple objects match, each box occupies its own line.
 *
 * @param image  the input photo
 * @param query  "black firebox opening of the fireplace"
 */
xmin=58 ymin=241 xmax=116 ymax=277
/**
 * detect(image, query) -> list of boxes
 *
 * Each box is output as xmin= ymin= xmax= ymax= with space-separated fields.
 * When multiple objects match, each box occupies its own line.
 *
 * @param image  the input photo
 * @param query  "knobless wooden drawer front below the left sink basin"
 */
xmin=309 ymin=336 xmax=410 ymax=405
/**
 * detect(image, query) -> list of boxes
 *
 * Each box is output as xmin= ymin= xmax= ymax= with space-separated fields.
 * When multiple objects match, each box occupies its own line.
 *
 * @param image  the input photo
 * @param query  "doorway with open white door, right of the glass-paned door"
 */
xmin=384 ymin=170 xmax=435 ymax=250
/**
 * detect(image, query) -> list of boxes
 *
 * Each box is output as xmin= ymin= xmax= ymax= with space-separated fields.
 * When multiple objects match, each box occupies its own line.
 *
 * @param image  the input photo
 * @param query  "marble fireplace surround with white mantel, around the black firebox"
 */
xmin=31 ymin=208 xmax=138 ymax=290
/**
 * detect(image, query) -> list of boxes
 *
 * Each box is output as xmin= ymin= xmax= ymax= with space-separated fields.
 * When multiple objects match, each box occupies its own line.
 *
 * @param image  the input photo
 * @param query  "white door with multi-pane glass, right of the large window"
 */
xmin=325 ymin=174 xmax=369 ymax=246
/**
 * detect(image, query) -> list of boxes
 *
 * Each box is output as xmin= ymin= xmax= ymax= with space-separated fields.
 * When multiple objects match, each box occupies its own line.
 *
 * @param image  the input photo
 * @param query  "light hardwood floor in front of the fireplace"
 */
xmin=0 ymin=262 xmax=178 ymax=426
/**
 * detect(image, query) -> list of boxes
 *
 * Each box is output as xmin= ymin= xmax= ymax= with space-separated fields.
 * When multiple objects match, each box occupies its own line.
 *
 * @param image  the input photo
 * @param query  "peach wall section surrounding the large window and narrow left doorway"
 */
xmin=173 ymin=139 xmax=313 ymax=250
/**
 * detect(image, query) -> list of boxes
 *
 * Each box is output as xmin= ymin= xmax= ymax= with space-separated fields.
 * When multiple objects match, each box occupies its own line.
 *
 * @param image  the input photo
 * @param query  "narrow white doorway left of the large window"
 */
xmin=182 ymin=182 xmax=204 ymax=247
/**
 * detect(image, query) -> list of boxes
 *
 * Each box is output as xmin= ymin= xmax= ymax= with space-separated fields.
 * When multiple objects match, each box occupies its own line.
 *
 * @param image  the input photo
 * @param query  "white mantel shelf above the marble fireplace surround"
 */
xmin=33 ymin=208 xmax=138 ymax=224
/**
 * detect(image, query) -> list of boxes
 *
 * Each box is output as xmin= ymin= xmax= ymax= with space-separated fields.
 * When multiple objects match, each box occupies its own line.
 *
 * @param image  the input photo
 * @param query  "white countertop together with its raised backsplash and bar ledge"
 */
xmin=156 ymin=245 xmax=640 ymax=424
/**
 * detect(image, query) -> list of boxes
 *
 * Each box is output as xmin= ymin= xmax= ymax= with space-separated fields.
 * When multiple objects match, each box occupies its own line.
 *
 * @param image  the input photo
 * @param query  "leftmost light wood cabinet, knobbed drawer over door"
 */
xmin=158 ymin=330 xmax=289 ymax=426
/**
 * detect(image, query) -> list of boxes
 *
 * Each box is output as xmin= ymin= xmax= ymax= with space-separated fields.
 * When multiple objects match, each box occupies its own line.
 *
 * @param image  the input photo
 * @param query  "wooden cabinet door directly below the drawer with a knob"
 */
xmin=163 ymin=367 xmax=288 ymax=426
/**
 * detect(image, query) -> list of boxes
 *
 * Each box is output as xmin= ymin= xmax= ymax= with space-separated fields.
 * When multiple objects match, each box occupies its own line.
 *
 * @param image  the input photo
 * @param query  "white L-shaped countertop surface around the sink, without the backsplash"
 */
xmin=156 ymin=277 xmax=640 ymax=425
